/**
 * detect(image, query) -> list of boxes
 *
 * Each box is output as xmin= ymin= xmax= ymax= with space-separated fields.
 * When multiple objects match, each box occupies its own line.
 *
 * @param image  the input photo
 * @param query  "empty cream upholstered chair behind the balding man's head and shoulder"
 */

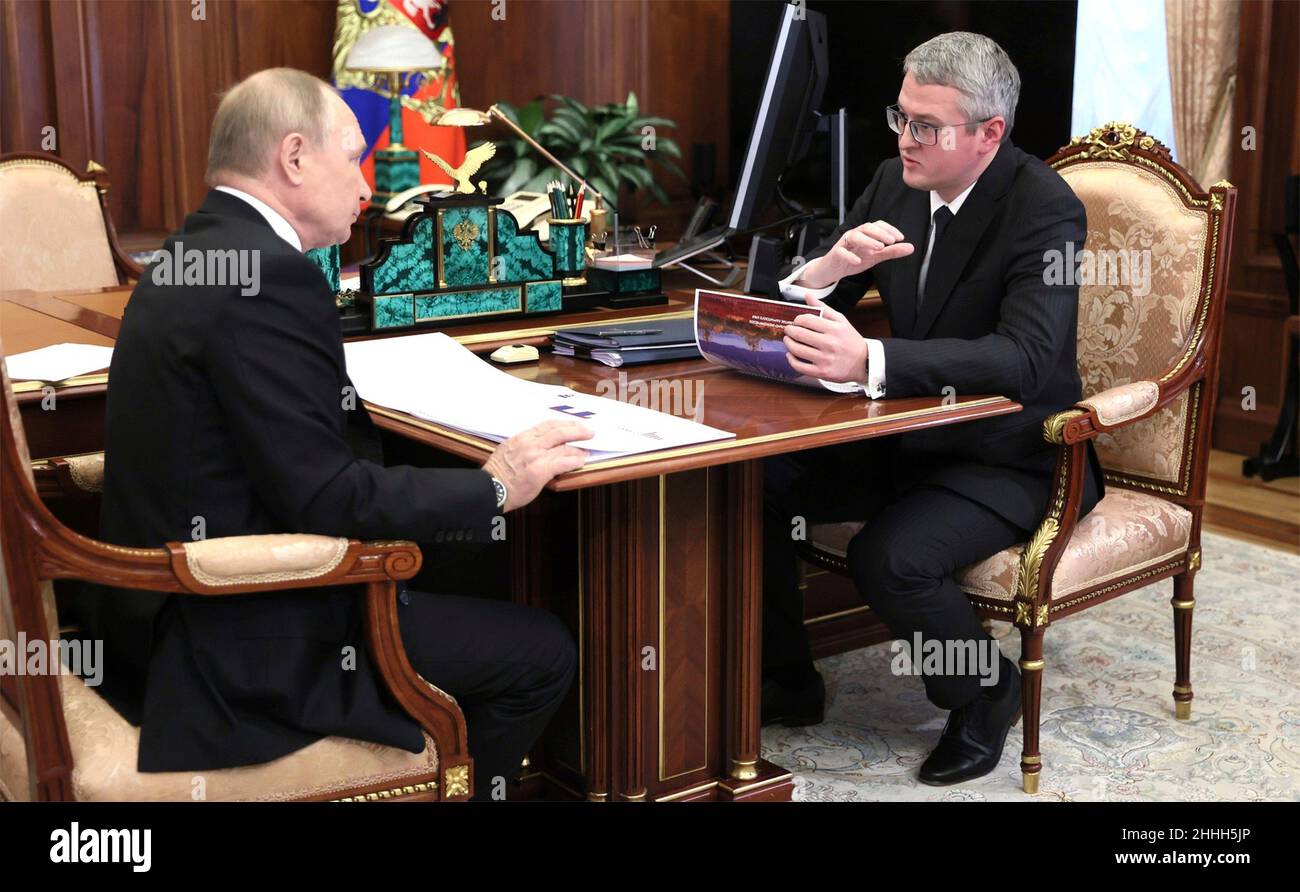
xmin=0 ymin=152 xmax=140 ymax=291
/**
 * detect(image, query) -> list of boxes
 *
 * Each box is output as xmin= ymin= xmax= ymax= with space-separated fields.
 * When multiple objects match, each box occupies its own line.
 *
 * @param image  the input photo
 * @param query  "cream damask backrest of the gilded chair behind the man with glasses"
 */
xmin=1048 ymin=122 xmax=1236 ymax=501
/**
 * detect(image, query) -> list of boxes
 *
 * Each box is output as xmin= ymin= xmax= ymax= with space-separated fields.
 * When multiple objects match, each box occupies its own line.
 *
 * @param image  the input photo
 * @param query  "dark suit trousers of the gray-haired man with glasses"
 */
xmin=763 ymin=438 xmax=1030 ymax=710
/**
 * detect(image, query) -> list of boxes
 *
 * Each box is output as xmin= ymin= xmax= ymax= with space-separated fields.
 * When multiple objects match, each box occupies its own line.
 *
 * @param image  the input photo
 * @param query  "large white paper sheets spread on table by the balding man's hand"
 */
xmin=343 ymin=332 xmax=736 ymax=462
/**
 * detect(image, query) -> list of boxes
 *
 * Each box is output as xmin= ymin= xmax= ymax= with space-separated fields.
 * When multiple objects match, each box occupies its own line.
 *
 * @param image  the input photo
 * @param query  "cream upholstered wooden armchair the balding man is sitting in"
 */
xmin=0 ymin=345 xmax=472 ymax=801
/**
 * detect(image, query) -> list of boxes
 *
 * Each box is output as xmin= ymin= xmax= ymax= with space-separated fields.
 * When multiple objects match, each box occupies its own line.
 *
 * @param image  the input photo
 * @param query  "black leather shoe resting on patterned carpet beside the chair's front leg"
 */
xmin=919 ymin=657 xmax=1021 ymax=787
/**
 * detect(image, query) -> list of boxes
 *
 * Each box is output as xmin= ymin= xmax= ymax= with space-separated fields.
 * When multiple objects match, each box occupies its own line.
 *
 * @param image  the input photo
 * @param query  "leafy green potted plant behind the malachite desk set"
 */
xmin=482 ymin=92 xmax=685 ymax=204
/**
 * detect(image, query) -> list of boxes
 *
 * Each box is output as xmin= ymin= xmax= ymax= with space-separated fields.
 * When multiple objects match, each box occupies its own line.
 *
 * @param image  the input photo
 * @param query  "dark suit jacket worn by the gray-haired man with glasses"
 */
xmin=781 ymin=142 xmax=1102 ymax=529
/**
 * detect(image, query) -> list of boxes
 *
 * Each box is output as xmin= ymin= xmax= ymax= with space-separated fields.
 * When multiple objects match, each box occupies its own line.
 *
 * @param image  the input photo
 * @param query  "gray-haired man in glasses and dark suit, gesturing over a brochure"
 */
xmin=763 ymin=33 xmax=1101 ymax=784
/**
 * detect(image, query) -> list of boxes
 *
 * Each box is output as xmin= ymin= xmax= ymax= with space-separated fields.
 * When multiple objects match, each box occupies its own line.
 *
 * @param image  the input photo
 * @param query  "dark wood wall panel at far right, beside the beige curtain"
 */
xmin=1201 ymin=0 xmax=1300 ymax=454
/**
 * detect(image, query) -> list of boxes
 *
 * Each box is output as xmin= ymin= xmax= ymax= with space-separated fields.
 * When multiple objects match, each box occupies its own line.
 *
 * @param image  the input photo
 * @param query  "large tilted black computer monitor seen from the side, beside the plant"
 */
xmin=727 ymin=5 xmax=828 ymax=231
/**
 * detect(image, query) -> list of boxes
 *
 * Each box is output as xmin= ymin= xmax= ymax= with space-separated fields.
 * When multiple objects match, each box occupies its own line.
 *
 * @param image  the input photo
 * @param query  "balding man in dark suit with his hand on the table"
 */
xmin=78 ymin=69 xmax=590 ymax=798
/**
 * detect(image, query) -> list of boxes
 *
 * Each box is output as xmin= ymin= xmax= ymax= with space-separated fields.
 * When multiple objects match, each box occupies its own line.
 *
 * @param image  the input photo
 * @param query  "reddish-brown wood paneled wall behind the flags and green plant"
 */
xmin=0 ymin=0 xmax=731 ymax=240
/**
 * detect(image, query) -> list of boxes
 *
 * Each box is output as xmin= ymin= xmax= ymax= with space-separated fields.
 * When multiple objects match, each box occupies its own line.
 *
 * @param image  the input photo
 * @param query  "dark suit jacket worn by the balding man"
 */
xmin=77 ymin=191 xmax=497 ymax=771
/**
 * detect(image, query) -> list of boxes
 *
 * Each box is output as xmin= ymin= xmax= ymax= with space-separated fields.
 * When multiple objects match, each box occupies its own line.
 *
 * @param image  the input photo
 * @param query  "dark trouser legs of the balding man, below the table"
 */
xmin=398 ymin=583 xmax=577 ymax=801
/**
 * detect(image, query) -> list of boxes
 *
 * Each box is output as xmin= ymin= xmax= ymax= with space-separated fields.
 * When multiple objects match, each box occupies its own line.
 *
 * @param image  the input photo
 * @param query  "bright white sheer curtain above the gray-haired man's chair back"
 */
xmin=1070 ymin=0 xmax=1178 ymax=161
